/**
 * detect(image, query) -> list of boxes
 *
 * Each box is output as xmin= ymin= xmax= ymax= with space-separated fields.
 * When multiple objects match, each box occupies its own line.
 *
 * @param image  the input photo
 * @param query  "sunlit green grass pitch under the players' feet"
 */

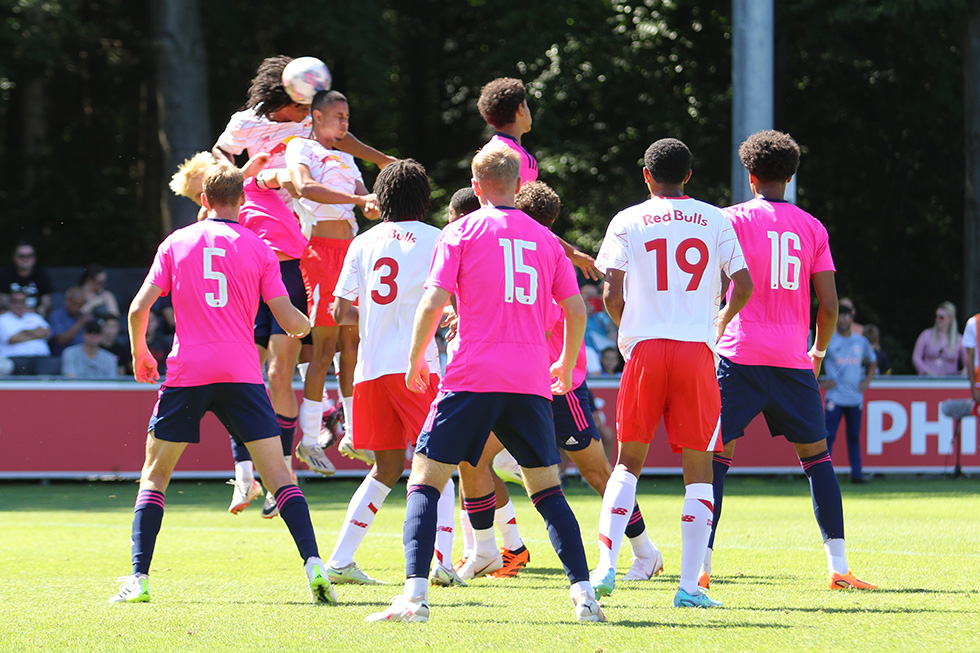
xmin=0 ymin=476 xmax=980 ymax=652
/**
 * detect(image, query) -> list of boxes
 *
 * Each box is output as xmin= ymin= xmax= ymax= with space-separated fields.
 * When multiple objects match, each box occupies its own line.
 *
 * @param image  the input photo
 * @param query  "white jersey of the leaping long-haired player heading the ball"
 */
xmin=216 ymin=109 xmax=313 ymax=208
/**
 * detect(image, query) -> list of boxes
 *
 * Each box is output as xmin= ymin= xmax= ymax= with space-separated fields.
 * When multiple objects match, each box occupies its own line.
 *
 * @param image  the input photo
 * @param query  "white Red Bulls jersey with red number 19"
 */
xmin=596 ymin=197 xmax=746 ymax=358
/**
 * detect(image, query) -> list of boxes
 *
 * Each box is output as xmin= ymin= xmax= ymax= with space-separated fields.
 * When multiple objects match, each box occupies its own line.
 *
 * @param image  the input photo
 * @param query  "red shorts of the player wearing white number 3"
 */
xmin=351 ymin=374 xmax=439 ymax=451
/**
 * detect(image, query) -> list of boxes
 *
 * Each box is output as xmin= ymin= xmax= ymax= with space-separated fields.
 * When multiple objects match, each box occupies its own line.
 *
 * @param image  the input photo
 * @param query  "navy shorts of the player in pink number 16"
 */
xmin=718 ymin=356 xmax=827 ymax=444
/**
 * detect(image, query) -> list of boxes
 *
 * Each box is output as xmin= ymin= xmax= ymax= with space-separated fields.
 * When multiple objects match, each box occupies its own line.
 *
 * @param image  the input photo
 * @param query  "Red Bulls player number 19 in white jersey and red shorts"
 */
xmin=592 ymin=138 xmax=752 ymax=608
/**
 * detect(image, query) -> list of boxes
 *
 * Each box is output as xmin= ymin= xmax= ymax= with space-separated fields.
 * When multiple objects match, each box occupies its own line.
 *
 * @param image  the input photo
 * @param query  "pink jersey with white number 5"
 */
xmin=146 ymin=220 xmax=286 ymax=387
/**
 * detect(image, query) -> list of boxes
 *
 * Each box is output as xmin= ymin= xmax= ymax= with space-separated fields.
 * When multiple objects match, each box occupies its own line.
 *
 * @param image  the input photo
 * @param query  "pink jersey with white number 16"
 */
xmin=717 ymin=199 xmax=834 ymax=369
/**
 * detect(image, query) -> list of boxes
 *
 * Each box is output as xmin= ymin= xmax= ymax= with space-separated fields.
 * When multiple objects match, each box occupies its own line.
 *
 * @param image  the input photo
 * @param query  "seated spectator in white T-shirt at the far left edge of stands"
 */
xmin=0 ymin=290 xmax=58 ymax=375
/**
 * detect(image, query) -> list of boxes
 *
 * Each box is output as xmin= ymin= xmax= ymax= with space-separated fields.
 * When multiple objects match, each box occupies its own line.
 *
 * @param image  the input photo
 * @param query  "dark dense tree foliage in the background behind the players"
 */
xmin=0 ymin=0 xmax=968 ymax=371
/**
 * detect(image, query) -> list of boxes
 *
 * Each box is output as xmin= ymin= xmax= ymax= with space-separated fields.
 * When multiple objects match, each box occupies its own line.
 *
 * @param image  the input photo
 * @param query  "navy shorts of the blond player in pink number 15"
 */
xmin=415 ymin=392 xmax=560 ymax=467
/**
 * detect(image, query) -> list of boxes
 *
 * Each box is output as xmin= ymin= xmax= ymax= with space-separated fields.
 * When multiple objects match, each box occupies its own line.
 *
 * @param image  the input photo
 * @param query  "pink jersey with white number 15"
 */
xmin=425 ymin=207 xmax=578 ymax=399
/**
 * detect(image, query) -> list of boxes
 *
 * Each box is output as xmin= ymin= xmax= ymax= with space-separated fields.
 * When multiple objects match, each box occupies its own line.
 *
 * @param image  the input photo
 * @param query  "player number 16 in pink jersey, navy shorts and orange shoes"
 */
xmin=699 ymin=131 xmax=876 ymax=589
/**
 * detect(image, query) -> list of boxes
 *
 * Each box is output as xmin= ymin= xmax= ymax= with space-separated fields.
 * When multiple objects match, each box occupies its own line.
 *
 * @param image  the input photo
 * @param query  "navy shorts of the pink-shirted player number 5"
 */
xmin=148 ymin=383 xmax=280 ymax=443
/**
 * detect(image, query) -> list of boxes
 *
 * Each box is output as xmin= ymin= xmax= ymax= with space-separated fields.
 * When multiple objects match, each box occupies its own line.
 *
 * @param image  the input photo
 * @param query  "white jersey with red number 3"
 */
xmin=334 ymin=221 xmax=440 ymax=383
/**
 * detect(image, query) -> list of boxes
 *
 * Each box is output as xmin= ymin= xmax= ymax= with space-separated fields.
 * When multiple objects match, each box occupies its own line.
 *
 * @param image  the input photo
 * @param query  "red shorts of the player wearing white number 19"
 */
xmin=616 ymin=339 xmax=723 ymax=453
